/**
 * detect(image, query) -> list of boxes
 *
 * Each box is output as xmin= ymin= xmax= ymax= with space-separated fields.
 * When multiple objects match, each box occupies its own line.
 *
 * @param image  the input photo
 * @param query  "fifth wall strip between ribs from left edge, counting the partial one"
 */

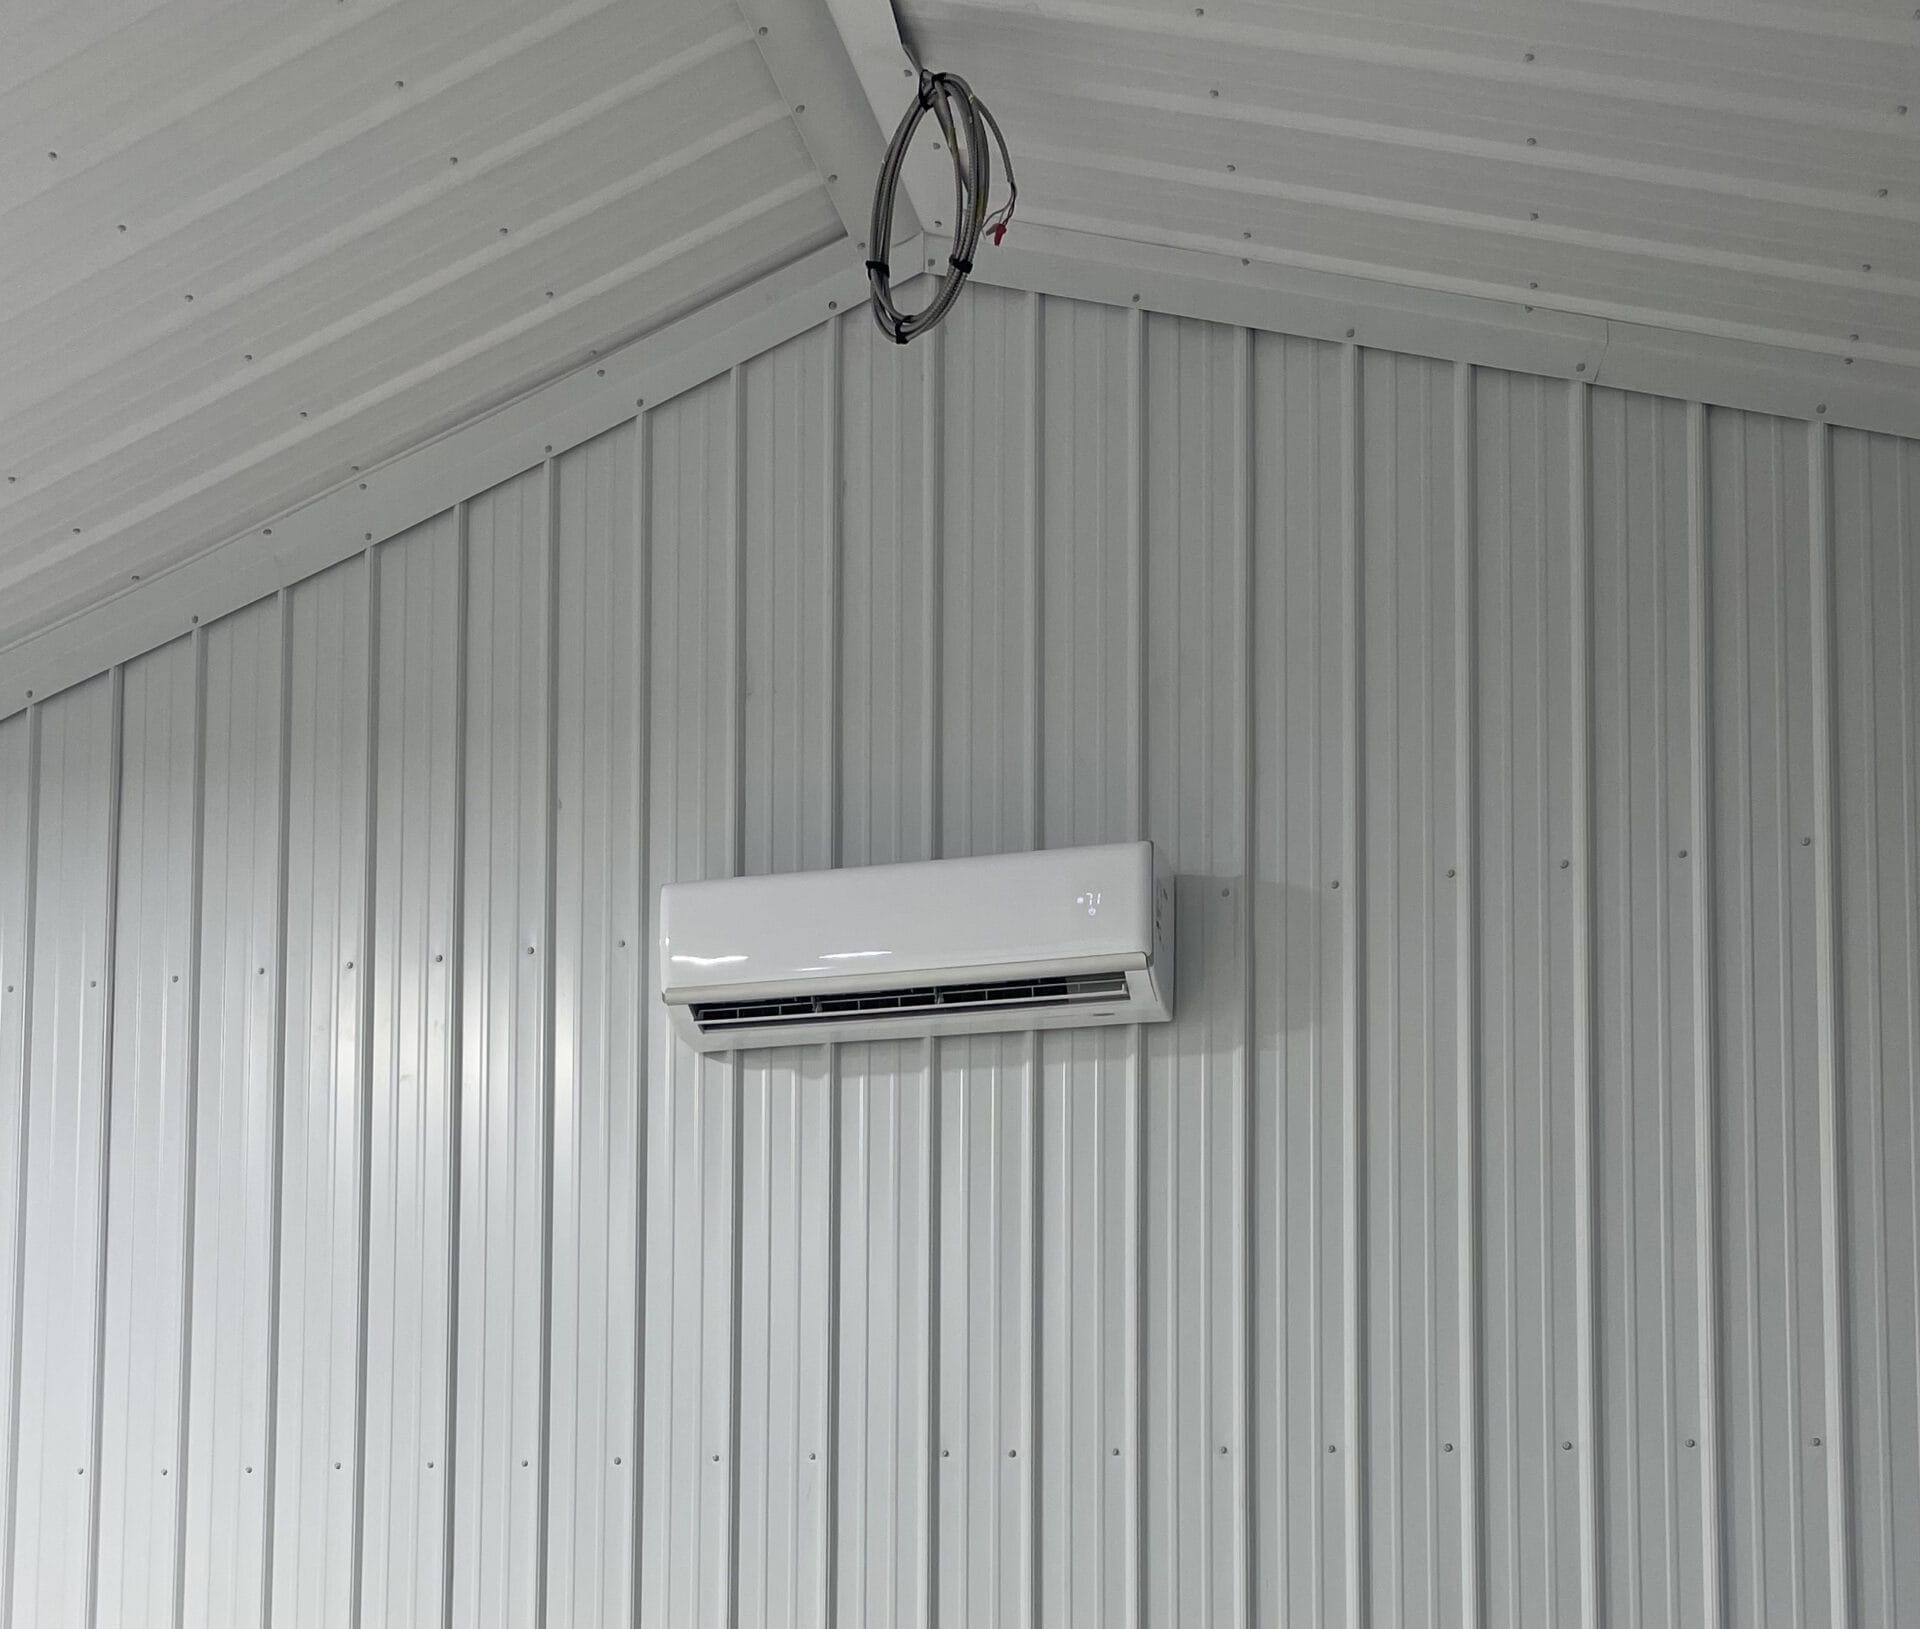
xmin=269 ymin=557 xmax=374 ymax=1625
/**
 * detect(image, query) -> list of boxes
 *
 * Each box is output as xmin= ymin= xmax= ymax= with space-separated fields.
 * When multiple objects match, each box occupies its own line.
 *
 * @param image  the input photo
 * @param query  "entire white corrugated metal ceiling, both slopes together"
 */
xmin=0 ymin=0 xmax=1920 ymax=668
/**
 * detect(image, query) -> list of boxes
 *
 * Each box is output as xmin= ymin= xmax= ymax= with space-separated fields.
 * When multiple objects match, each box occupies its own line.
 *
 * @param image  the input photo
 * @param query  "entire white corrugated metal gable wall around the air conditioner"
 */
xmin=0 ymin=290 xmax=1920 ymax=1629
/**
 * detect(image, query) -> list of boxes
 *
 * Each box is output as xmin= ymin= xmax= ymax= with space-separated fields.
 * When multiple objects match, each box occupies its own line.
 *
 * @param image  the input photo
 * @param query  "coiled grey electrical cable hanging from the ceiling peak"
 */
xmin=866 ymin=69 xmax=1020 ymax=346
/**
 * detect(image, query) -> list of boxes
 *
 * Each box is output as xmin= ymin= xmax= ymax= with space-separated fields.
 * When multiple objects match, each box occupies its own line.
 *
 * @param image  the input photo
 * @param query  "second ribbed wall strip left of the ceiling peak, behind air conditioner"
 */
xmin=737 ymin=328 xmax=839 ymax=1625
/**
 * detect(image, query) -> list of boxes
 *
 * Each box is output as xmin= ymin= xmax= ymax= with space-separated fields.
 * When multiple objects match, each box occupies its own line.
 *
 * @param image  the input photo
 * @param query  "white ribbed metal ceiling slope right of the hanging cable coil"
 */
xmin=900 ymin=0 xmax=1920 ymax=371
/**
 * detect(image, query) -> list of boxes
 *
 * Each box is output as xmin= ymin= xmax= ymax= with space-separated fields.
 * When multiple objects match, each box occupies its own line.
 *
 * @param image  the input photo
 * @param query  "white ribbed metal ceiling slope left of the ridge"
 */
xmin=0 ymin=0 xmax=841 ymax=645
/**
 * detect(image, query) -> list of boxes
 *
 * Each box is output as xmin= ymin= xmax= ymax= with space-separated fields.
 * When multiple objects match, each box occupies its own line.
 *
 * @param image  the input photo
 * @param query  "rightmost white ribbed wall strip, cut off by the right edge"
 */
xmin=1834 ymin=432 xmax=1920 ymax=1623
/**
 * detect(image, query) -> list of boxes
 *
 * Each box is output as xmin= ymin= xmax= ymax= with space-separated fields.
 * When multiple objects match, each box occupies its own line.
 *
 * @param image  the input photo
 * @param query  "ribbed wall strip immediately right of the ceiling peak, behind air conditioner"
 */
xmin=933 ymin=290 xmax=1041 ymax=1623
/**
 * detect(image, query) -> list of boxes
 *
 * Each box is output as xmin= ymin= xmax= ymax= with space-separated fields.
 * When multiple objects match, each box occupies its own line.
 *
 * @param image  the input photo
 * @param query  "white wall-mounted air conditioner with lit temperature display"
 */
xmin=660 ymin=843 xmax=1173 ymax=1053
